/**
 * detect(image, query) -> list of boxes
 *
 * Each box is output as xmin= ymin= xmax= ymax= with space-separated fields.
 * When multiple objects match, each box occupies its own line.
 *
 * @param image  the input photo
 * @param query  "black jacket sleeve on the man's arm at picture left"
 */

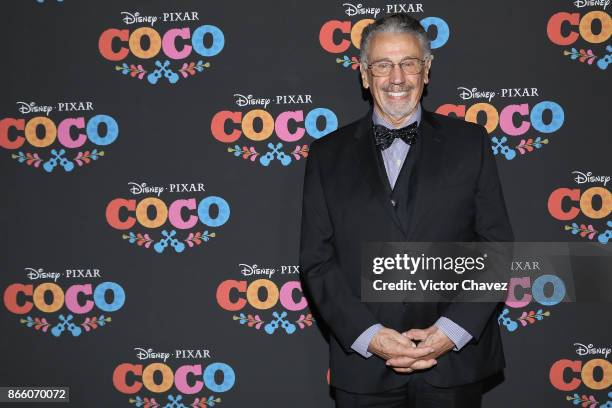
xmin=300 ymin=142 xmax=378 ymax=353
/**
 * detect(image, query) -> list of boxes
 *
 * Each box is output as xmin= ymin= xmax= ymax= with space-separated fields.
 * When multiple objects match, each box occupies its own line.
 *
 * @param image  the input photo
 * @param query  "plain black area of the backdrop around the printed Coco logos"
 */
xmin=0 ymin=0 xmax=612 ymax=407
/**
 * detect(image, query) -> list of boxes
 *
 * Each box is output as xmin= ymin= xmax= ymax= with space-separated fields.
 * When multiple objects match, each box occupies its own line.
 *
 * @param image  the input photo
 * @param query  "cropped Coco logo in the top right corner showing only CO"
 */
xmin=546 ymin=5 xmax=612 ymax=71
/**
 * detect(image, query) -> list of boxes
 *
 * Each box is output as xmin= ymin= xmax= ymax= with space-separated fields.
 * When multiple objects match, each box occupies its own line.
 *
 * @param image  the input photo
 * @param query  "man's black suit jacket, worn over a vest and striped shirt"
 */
xmin=300 ymin=107 xmax=513 ymax=393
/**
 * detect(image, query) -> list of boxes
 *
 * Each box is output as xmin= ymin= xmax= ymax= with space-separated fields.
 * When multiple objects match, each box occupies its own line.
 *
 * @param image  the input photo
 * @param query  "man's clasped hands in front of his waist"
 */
xmin=368 ymin=326 xmax=455 ymax=373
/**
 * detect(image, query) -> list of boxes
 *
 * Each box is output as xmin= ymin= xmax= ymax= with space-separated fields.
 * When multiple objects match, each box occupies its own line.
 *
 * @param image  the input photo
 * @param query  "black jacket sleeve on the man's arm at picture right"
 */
xmin=443 ymin=127 xmax=514 ymax=342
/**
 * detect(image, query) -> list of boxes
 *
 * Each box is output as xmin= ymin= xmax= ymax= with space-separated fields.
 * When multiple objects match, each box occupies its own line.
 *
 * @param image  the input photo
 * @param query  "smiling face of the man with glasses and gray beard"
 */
xmin=360 ymin=32 xmax=431 ymax=126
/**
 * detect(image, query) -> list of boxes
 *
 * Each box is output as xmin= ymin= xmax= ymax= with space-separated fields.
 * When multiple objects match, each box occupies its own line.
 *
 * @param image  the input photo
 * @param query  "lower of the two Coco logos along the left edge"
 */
xmin=3 ymin=268 xmax=126 ymax=337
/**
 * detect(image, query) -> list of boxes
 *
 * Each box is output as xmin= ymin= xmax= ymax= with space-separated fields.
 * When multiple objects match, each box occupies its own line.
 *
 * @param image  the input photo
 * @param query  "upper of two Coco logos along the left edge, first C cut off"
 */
xmin=0 ymin=101 xmax=119 ymax=173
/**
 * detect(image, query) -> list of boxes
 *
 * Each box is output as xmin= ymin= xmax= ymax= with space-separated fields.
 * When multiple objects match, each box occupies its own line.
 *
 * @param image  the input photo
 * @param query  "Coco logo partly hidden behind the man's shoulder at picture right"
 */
xmin=436 ymin=87 xmax=565 ymax=160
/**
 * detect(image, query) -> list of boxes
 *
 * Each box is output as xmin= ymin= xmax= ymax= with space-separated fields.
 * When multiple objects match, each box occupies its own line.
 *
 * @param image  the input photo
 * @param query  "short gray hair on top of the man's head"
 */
xmin=359 ymin=13 xmax=431 ymax=64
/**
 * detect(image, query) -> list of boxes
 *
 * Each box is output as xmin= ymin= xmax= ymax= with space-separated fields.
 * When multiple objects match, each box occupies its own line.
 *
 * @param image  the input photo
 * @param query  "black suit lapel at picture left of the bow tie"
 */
xmin=355 ymin=110 xmax=406 ymax=238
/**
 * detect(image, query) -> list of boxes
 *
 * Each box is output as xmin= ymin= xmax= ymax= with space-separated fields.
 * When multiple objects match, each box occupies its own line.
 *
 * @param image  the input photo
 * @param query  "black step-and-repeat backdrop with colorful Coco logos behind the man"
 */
xmin=0 ymin=0 xmax=612 ymax=408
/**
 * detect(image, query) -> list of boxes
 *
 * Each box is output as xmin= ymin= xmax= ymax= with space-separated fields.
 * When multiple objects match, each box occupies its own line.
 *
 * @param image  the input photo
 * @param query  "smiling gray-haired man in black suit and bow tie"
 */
xmin=300 ymin=14 xmax=513 ymax=408
